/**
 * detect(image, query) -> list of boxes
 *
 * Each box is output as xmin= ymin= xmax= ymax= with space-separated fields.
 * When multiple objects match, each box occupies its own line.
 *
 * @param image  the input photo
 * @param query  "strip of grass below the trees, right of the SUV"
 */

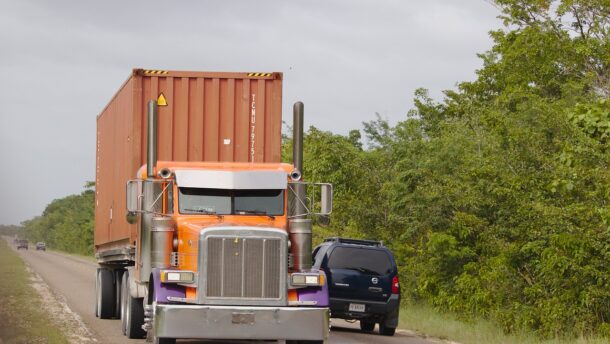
xmin=398 ymin=304 xmax=608 ymax=344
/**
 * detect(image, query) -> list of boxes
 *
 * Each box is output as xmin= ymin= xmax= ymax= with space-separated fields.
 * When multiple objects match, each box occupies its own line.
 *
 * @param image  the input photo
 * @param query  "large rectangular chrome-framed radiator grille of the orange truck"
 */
xmin=200 ymin=230 xmax=287 ymax=304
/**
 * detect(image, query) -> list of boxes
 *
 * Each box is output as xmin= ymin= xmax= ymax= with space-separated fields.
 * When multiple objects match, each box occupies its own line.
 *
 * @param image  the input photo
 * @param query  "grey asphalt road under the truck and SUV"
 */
xmin=11 ymin=245 xmax=434 ymax=344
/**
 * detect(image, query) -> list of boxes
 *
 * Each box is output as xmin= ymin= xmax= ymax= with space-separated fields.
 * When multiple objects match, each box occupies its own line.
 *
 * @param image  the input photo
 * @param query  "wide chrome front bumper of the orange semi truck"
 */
xmin=154 ymin=304 xmax=330 ymax=340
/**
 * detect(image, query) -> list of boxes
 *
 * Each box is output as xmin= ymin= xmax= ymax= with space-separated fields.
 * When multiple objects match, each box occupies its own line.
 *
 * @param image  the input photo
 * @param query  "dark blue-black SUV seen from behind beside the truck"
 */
xmin=313 ymin=238 xmax=400 ymax=336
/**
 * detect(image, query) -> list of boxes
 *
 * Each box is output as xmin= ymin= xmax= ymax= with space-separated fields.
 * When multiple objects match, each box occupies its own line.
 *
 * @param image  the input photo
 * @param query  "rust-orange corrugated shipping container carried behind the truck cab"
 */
xmin=95 ymin=69 xmax=282 ymax=251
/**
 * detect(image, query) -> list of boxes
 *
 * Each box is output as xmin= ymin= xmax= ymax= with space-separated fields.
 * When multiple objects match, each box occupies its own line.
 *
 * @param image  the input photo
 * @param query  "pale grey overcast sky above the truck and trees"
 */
xmin=0 ymin=0 xmax=501 ymax=224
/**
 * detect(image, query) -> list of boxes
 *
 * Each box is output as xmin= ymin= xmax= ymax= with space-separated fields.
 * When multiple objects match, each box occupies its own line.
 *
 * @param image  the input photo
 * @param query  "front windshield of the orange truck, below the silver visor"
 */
xmin=178 ymin=187 xmax=284 ymax=216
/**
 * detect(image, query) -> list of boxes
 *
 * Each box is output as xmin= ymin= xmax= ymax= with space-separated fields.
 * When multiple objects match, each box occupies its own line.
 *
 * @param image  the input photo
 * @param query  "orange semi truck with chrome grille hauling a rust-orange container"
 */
xmin=95 ymin=69 xmax=332 ymax=344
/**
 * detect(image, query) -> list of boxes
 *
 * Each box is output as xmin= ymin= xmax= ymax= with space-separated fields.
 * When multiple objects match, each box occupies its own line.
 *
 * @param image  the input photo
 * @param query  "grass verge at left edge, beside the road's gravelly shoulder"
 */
xmin=0 ymin=238 xmax=68 ymax=344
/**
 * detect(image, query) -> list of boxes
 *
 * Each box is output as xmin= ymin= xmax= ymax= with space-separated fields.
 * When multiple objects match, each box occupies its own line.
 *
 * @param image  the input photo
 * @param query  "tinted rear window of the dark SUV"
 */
xmin=328 ymin=246 xmax=392 ymax=275
